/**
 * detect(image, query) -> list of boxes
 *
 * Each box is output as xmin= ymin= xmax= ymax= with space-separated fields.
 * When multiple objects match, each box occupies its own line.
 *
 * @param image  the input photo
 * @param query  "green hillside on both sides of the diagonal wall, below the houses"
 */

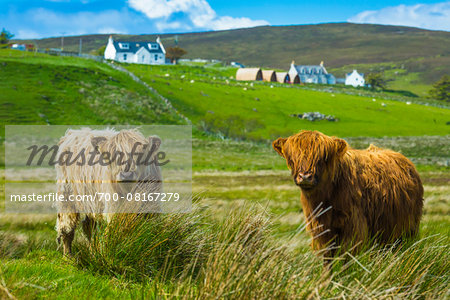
xmin=0 ymin=50 xmax=450 ymax=140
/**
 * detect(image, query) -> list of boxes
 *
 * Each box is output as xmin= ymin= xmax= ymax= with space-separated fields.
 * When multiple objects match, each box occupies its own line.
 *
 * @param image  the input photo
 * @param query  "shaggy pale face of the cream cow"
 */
xmin=91 ymin=130 xmax=161 ymax=183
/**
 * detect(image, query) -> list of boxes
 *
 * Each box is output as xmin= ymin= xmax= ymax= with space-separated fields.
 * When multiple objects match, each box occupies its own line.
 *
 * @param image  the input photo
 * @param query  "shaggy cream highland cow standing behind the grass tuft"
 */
xmin=56 ymin=128 xmax=162 ymax=254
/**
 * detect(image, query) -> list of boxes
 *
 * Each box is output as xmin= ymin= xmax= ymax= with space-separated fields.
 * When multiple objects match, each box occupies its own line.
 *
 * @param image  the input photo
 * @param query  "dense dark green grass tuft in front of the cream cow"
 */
xmin=76 ymin=214 xmax=208 ymax=281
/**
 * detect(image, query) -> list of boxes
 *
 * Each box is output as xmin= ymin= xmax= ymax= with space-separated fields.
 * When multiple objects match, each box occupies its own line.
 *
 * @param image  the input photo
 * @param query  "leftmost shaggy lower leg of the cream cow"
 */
xmin=56 ymin=213 xmax=80 ymax=255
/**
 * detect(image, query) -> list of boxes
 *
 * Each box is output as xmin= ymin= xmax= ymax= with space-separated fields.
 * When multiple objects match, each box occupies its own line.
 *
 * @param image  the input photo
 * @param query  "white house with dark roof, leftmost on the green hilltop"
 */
xmin=104 ymin=36 xmax=166 ymax=65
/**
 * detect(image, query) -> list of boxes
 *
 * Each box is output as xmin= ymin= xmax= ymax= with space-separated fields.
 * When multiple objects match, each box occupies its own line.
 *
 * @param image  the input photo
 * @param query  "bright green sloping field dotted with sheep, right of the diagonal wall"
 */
xmin=126 ymin=65 xmax=450 ymax=140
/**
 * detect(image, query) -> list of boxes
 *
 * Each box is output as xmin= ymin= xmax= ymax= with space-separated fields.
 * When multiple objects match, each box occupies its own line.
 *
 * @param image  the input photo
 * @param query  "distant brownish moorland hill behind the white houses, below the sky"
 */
xmin=18 ymin=23 xmax=450 ymax=96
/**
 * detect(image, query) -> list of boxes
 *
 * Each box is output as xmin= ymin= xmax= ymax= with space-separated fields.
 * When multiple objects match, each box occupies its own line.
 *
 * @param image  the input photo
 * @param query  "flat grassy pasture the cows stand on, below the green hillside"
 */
xmin=0 ymin=137 xmax=450 ymax=299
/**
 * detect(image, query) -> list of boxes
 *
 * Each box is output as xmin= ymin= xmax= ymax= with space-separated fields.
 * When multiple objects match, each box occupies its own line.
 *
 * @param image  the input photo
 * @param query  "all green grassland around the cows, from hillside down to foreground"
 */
xmin=0 ymin=51 xmax=450 ymax=299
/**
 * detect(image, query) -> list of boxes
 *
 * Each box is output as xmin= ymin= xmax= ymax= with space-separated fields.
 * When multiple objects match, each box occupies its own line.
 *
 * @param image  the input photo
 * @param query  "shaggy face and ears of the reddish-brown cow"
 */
xmin=272 ymin=131 xmax=348 ymax=190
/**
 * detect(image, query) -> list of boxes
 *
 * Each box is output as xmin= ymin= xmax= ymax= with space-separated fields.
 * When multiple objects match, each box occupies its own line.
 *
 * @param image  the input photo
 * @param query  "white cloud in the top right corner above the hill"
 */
xmin=348 ymin=2 xmax=450 ymax=31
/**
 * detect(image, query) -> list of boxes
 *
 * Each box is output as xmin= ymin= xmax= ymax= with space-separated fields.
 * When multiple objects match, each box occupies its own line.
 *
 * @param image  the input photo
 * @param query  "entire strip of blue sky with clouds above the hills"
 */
xmin=0 ymin=0 xmax=450 ymax=38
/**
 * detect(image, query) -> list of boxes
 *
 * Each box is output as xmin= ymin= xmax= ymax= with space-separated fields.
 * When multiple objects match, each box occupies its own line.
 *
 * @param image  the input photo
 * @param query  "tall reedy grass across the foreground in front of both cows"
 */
xmin=71 ymin=207 xmax=450 ymax=299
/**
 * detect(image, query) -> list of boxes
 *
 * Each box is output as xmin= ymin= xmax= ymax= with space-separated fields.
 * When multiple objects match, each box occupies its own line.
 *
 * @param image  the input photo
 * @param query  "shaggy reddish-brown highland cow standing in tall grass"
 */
xmin=272 ymin=130 xmax=423 ymax=259
